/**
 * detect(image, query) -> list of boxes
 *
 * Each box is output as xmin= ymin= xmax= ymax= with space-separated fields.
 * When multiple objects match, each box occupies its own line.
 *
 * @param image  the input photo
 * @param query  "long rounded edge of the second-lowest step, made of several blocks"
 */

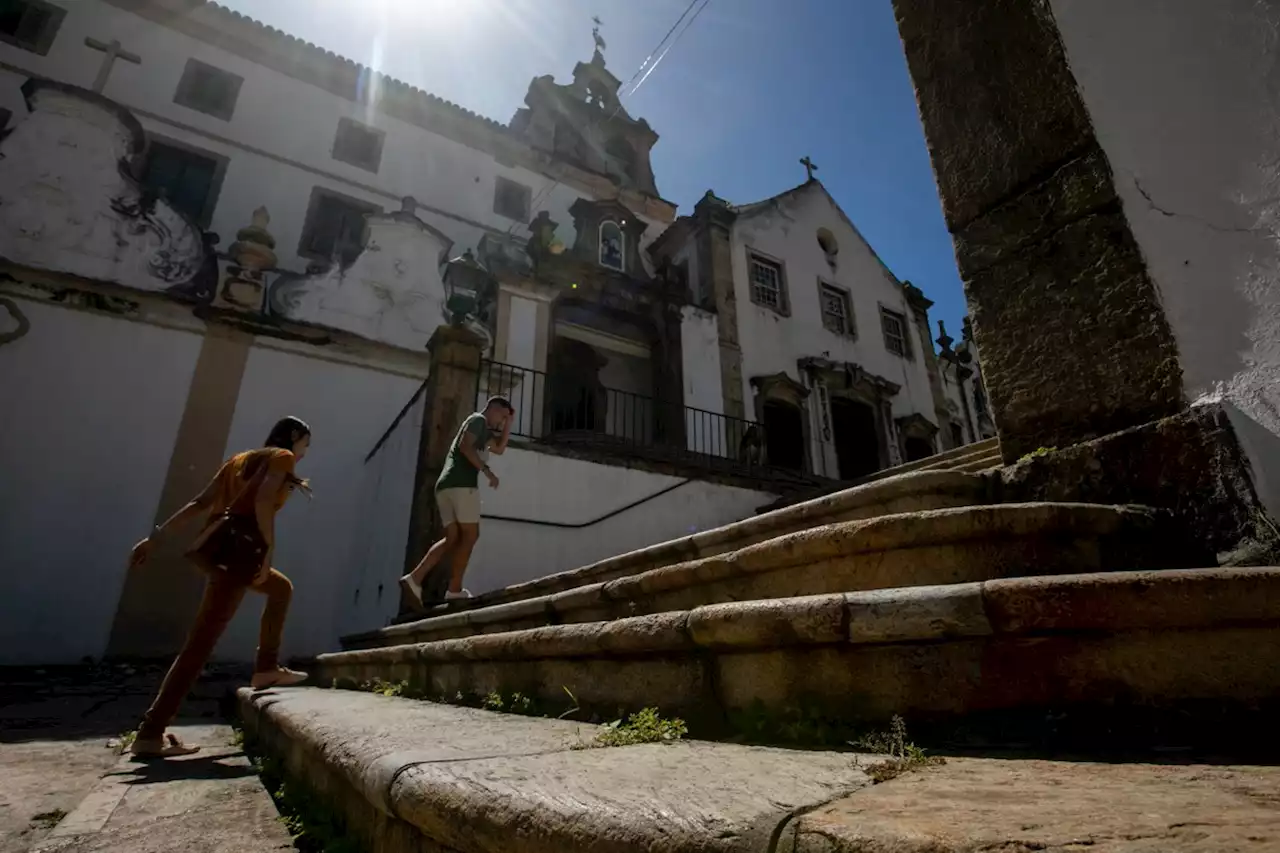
xmin=316 ymin=567 xmax=1280 ymax=669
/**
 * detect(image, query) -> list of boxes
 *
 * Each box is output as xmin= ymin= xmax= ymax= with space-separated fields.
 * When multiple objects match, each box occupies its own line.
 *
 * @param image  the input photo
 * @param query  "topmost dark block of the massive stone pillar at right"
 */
xmin=893 ymin=0 xmax=1093 ymax=229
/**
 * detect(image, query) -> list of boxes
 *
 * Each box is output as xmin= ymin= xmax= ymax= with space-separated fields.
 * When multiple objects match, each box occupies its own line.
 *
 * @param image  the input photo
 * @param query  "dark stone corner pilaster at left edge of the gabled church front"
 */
xmin=694 ymin=190 xmax=746 ymax=422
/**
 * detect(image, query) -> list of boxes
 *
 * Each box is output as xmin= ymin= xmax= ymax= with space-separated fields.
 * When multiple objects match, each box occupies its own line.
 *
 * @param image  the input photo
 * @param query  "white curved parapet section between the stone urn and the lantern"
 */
xmin=269 ymin=199 xmax=452 ymax=350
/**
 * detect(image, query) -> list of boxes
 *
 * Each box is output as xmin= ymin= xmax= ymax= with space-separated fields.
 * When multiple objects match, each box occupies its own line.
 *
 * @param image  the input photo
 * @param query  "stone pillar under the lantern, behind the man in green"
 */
xmin=401 ymin=325 xmax=483 ymax=601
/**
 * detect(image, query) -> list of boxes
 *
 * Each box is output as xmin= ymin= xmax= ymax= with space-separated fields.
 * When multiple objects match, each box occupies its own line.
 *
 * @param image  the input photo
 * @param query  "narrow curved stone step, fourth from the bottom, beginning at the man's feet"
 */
xmin=371 ymin=471 xmax=998 ymax=635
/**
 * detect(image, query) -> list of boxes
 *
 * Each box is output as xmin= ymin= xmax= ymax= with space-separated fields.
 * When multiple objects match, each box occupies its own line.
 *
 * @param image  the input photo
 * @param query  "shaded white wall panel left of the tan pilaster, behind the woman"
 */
xmin=0 ymin=300 xmax=201 ymax=663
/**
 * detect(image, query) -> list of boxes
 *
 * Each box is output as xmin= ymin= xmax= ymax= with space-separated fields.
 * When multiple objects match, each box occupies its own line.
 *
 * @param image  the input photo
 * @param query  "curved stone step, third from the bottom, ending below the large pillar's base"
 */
xmin=342 ymin=499 xmax=1211 ymax=649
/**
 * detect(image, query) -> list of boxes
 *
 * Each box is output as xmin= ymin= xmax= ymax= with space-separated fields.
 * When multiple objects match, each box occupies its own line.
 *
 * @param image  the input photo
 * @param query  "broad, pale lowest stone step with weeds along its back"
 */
xmin=238 ymin=688 xmax=1280 ymax=853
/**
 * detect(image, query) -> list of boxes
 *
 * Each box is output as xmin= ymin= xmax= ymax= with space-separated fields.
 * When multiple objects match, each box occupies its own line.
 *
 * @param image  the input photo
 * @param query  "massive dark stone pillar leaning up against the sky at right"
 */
xmin=893 ymin=0 xmax=1187 ymax=462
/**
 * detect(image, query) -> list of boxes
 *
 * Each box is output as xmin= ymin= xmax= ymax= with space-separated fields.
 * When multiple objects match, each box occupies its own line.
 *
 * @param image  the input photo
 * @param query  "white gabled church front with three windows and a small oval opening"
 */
xmin=732 ymin=188 xmax=936 ymax=421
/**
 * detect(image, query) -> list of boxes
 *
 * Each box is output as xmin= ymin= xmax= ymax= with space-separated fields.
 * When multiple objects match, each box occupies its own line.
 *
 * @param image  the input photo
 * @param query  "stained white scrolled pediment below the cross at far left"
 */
xmin=0 ymin=78 xmax=207 ymax=292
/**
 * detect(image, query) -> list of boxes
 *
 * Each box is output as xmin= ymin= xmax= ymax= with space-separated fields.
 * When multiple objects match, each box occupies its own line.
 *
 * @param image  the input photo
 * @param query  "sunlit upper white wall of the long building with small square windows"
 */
xmin=0 ymin=0 xmax=662 ymax=272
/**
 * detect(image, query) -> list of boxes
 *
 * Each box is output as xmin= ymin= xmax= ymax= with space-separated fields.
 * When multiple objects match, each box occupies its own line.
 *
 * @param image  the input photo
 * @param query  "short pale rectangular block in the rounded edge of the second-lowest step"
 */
xmin=845 ymin=583 xmax=991 ymax=643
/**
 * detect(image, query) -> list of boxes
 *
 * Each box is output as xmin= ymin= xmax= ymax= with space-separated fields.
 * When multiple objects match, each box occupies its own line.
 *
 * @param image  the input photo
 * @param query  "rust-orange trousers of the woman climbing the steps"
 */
xmin=138 ymin=569 xmax=293 ymax=739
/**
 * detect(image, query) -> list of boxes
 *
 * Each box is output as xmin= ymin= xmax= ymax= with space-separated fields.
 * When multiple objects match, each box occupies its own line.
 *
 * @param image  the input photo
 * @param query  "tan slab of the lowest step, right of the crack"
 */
xmin=778 ymin=760 xmax=1280 ymax=853
